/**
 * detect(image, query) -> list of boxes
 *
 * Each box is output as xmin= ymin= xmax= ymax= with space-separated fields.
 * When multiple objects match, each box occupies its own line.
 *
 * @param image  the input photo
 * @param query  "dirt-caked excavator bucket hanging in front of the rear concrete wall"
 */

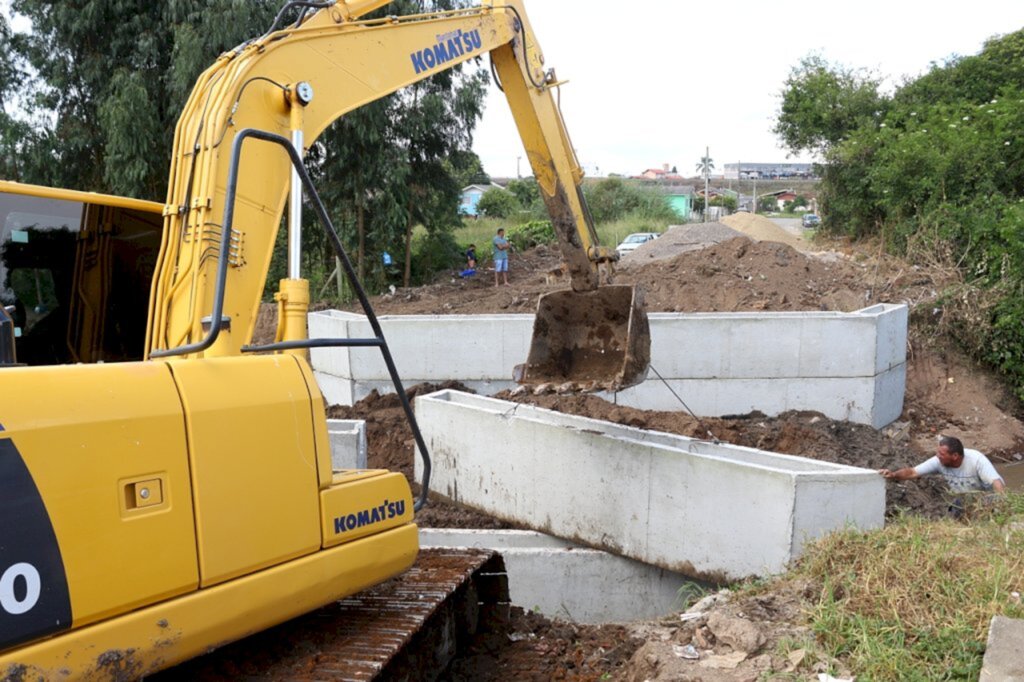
xmin=514 ymin=286 xmax=650 ymax=391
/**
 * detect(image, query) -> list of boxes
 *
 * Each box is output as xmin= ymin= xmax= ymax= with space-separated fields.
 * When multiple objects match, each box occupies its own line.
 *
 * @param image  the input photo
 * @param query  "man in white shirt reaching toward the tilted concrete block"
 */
xmin=879 ymin=436 xmax=1007 ymax=509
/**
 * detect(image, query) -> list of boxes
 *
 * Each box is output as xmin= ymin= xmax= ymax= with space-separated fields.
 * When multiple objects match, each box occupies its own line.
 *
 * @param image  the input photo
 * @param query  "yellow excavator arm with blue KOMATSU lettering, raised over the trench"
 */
xmin=146 ymin=0 xmax=649 ymax=385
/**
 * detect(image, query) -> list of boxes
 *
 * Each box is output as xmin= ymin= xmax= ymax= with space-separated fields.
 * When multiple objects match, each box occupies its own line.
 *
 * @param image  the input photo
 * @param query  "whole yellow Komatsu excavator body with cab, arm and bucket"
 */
xmin=0 ymin=0 xmax=649 ymax=680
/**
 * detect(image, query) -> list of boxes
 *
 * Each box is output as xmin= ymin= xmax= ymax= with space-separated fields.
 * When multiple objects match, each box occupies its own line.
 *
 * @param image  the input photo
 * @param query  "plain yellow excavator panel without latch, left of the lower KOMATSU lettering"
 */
xmin=163 ymin=355 xmax=321 ymax=587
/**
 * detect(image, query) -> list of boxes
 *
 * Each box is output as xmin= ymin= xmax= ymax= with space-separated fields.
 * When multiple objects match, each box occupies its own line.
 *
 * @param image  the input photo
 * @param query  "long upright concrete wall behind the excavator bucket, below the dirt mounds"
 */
xmin=309 ymin=304 xmax=907 ymax=428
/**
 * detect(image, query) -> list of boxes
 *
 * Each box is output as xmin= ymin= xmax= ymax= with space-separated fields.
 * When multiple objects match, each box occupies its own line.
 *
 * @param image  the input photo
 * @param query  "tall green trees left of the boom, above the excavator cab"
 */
xmin=11 ymin=0 xmax=278 ymax=196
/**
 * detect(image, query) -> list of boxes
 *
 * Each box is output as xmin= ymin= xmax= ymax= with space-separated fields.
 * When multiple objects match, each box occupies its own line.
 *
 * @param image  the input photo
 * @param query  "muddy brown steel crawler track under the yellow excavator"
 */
xmin=146 ymin=548 xmax=509 ymax=681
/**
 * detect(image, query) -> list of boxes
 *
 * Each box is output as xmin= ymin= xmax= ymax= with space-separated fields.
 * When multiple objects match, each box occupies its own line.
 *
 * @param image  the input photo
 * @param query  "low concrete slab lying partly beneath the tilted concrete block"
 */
xmin=420 ymin=528 xmax=706 ymax=624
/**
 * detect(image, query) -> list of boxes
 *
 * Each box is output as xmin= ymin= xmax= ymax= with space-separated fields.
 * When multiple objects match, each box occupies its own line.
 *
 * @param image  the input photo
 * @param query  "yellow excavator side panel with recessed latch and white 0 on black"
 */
xmin=0 ymin=363 xmax=199 ymax=650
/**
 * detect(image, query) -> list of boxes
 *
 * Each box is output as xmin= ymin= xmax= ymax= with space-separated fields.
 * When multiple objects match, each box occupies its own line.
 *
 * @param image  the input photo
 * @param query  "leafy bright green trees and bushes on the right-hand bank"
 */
xmin=775 ymin=31 xmax=1024 ymax=396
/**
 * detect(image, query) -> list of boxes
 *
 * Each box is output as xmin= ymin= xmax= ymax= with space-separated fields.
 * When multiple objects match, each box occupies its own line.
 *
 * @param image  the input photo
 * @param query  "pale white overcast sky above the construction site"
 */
xmin=473 ymin=0 xmax=1024 ymax=177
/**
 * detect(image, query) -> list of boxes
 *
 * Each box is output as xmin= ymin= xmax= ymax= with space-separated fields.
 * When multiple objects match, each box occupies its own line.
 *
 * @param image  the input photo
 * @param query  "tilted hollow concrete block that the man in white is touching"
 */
xmin=416 ymin=391 xmax=885 ymax=582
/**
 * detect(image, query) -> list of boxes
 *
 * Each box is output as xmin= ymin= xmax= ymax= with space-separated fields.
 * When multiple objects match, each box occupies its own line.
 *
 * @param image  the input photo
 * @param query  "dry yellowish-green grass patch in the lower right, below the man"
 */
xmin=767 ymin=495 xmax=1024 ymax=680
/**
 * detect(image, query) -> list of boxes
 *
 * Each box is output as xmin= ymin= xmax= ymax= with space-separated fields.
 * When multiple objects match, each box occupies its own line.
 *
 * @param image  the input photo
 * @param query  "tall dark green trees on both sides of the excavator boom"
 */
xmin=7 ymin=0 xmax=487 ymax=294
